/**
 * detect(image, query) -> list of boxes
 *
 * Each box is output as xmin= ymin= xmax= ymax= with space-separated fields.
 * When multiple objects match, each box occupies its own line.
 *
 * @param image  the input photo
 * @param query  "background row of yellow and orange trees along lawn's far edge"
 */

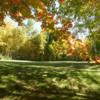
xmin=0 ymin=22 xmax=97 ymax=61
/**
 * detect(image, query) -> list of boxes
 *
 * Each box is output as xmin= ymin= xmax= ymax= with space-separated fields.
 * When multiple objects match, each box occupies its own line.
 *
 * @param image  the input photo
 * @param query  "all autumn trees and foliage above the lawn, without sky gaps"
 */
xmin=0 ymin=0 xmax=100 ymax=60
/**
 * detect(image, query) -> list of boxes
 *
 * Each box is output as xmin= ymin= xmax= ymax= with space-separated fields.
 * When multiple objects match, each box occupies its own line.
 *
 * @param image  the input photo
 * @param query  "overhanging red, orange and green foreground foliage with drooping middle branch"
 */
xmin=0 ymin=0 xmax=100 ymax=60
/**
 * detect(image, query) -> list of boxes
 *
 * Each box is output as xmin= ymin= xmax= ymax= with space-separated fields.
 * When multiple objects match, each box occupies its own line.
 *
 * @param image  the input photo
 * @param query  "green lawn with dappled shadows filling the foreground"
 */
xmin=0 ymin=61 xmax=100 ymax=100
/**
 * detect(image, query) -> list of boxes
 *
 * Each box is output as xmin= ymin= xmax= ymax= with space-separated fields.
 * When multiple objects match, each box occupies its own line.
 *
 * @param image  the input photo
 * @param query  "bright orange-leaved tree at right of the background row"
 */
xmin=67 ymin=38 xmax=89 ymax=61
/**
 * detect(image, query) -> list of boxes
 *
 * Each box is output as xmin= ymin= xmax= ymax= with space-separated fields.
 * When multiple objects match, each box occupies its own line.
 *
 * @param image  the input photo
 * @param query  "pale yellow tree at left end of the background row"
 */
xmin=0 ymin=24 xmax=26 ymax=58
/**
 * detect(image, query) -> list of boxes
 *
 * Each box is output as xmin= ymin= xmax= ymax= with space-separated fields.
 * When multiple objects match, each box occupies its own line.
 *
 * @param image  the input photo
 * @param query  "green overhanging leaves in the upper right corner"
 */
xmin=60 ymin=0 xmax=100 ymax=30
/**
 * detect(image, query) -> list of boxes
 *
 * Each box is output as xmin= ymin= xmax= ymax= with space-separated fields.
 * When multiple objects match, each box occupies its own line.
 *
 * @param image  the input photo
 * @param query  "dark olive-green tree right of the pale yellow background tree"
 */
xmin=18 ymin=33 xmax=46 ymax=60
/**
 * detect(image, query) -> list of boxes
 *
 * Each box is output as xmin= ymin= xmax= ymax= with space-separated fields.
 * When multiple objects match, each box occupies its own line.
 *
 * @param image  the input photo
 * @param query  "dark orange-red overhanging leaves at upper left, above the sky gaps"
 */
xmin=0 ymin=0 xmax=55 ymax=28
